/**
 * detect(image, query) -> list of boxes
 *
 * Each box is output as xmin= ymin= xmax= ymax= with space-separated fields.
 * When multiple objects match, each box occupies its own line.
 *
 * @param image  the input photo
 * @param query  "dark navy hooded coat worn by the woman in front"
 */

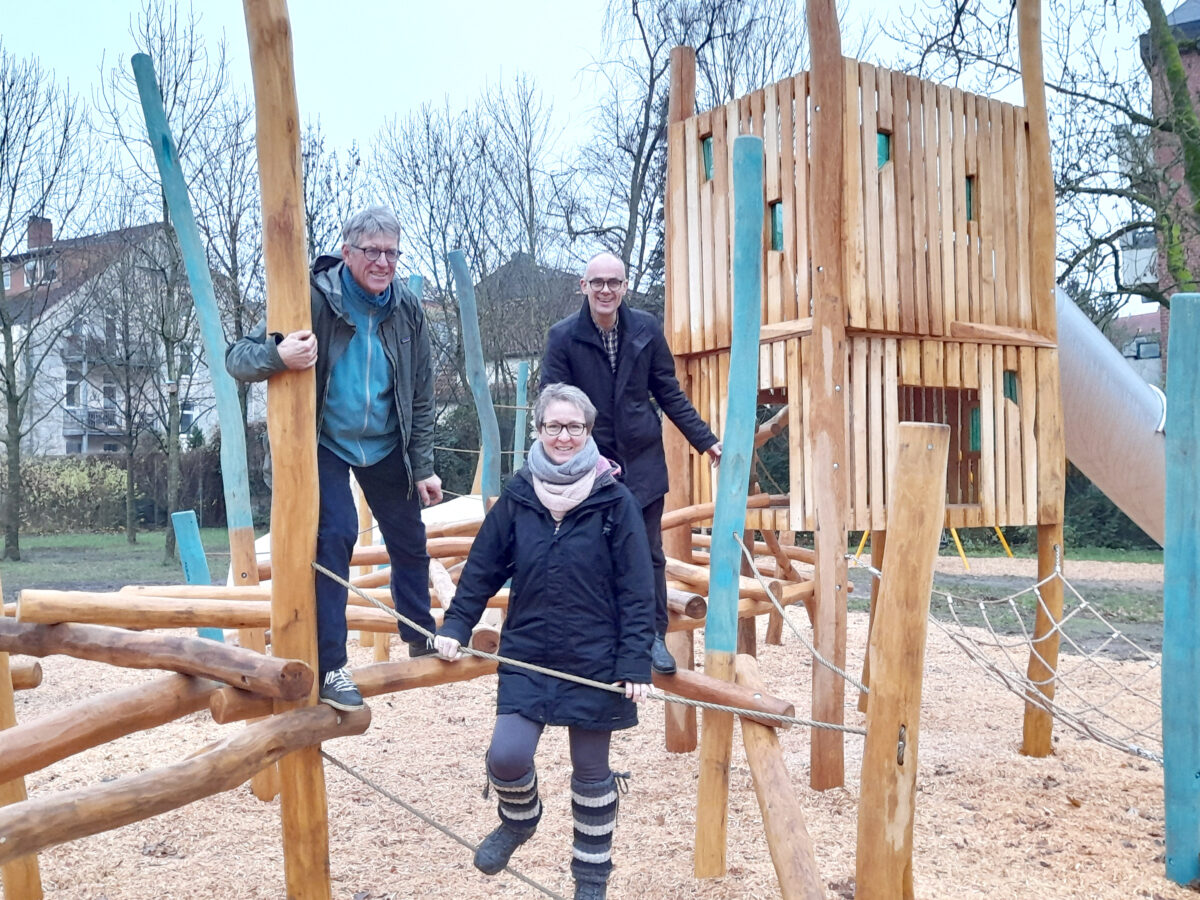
xmin=438 ymin=469 xmax=654 ymax=731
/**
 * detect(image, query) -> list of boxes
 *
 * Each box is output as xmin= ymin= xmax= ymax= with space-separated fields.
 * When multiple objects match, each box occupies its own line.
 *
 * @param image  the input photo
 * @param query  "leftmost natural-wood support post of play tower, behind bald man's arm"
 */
xmin=662 ymin=47 xmax=696 ymax=754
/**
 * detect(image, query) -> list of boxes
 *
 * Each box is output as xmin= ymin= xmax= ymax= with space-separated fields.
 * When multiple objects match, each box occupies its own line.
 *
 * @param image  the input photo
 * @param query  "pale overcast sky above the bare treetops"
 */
xmin=0 ymin=0 xmax=916 ymax=151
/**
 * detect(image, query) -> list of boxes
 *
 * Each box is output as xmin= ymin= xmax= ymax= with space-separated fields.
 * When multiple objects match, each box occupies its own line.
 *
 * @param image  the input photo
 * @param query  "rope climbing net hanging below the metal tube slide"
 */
xmin=854 ymin=560 xmax=1163 ymax=766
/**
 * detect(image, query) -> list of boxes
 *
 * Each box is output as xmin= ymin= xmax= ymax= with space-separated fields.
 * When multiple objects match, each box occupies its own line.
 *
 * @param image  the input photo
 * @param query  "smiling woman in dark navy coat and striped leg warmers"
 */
xmin=433 ymin=384 xmax=654 ymax=900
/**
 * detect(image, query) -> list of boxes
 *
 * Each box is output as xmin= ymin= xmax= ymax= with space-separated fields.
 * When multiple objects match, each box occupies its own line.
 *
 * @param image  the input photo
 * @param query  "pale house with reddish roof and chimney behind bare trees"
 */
xmin=0 ymin=216 xmax=216 ymax=455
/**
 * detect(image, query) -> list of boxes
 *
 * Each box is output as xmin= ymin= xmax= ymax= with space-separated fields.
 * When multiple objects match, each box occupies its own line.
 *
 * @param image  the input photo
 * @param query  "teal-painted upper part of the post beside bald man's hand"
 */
xmin=704 ymin=134 xmax=763 ymax=653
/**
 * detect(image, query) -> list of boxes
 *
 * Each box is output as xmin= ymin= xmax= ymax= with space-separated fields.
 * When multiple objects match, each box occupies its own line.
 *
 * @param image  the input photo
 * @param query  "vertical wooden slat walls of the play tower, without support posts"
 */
xmin=667 ymin=59 xmax=1046 ymax=540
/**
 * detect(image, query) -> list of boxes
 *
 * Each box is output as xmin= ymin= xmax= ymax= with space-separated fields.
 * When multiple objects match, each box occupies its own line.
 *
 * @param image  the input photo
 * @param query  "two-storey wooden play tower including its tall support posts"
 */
xmin=665 ymin=2 xmax=1066 ymax=787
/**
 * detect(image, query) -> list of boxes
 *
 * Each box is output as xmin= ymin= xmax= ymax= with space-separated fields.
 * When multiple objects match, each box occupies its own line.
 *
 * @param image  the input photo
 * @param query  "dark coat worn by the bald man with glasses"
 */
xmin=540 ymin=300 xmax=716 ymax=506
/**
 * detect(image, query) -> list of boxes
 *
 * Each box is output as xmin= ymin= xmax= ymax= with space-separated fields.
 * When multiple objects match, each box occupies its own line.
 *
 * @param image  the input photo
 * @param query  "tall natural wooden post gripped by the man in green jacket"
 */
xmin=244 ymin=0 xmax=330 ymax=900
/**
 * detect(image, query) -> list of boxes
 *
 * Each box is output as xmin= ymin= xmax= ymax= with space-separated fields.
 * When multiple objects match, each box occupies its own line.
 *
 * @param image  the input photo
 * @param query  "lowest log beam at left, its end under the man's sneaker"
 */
xmin=0 ymin=706 xmax=371 ymax=863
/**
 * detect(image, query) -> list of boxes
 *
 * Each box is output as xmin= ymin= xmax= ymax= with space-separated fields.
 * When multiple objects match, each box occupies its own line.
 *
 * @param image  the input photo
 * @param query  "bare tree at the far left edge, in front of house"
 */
xmin=0 ymin=42 xmax=92 ymax=559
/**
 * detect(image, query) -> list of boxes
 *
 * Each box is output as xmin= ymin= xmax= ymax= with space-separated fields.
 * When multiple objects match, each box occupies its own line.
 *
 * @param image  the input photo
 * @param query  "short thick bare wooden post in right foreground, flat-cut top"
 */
xmin=854 ymin=422 xmax=950 ymax=900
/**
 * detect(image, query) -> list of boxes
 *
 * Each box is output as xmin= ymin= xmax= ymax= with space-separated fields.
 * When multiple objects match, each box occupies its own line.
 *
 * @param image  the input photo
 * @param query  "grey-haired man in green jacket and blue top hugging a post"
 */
xmin=226 ymin=206 xmax=442 ymax=710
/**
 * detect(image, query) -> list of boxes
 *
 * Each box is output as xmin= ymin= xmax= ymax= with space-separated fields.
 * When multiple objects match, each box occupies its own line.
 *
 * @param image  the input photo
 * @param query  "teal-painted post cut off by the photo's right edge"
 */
xmin=1163 ymin=294 xmax=1200 ymax=884
